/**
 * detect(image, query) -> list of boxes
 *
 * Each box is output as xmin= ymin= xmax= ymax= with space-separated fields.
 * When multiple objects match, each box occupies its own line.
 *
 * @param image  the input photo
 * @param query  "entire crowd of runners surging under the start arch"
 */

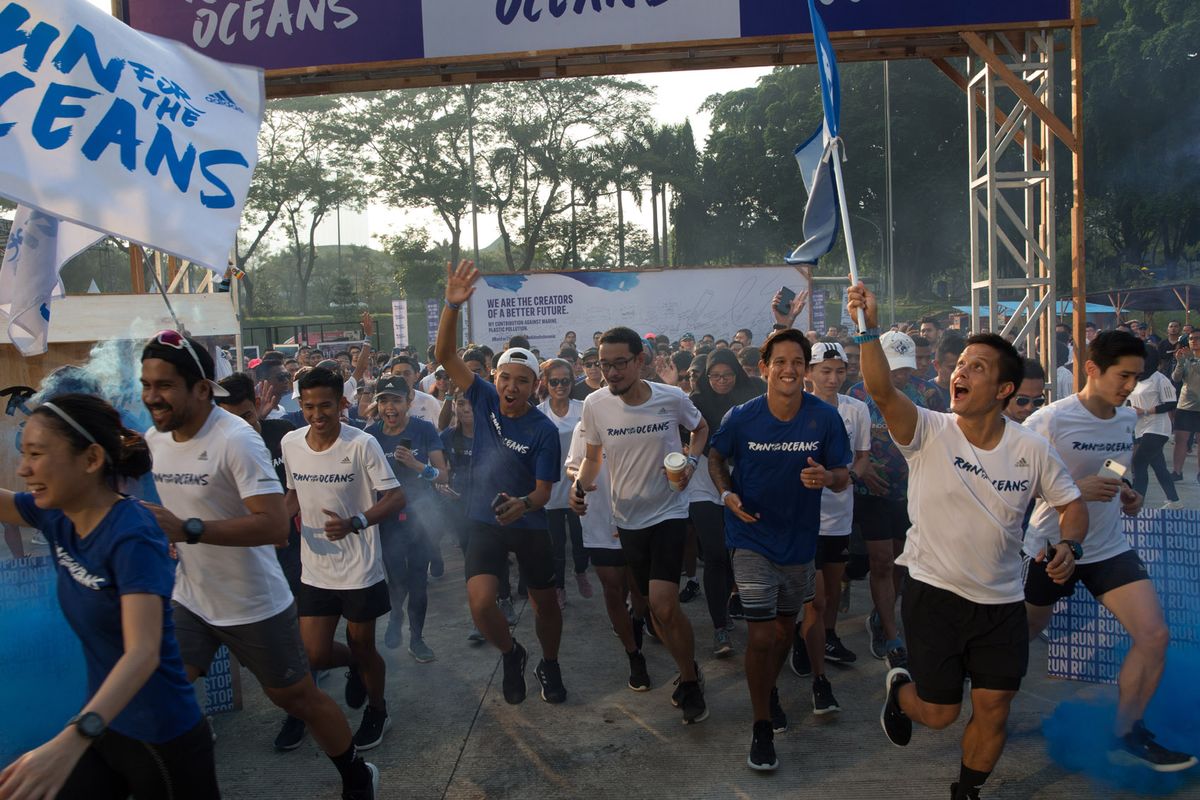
xmin=0 ymin=263 xmax=1200 ymax=800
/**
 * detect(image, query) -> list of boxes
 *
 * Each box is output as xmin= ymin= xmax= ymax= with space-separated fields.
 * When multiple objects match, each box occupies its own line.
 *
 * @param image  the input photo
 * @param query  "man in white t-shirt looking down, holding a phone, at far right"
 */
xmin=1025 ymin=331 xmax=1196 ymax=772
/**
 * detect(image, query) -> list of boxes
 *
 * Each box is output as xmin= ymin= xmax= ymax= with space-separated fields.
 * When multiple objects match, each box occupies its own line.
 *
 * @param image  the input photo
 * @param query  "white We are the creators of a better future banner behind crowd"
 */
xmin=469 ymin=266 xmax=811 ymax=355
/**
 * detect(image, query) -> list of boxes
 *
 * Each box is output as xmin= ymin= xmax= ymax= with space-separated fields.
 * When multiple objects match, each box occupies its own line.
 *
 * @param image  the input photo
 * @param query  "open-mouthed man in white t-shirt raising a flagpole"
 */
xmin=846 ymin=283 xmax=1087 ymax=800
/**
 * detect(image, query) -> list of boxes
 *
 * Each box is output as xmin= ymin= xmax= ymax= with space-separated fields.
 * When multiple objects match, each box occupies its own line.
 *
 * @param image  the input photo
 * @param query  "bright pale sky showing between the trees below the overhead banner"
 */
xmin=89 ymin=0 xmax=770 ymax=247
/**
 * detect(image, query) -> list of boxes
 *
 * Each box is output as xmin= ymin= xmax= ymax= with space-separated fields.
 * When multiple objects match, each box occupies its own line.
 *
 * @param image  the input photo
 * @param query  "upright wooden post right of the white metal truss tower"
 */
xmin=1070 ymin=0 xmax=1087 ymax=392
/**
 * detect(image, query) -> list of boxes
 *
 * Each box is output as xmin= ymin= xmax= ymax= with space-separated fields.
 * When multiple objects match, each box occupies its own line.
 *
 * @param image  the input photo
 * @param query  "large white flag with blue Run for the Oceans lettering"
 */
xmin=0 ymin=0 xmax=265 ymax=272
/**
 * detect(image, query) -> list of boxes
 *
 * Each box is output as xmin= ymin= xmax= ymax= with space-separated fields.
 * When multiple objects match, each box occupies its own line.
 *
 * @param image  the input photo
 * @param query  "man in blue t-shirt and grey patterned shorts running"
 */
xmin=708 ymin=329 xmax=853 ymax=770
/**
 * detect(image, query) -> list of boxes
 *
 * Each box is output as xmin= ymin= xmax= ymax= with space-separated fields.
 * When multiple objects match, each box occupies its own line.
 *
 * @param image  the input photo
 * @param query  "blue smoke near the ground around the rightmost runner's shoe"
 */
xmin=1042 ymin=631 xmax=1200 ymax=795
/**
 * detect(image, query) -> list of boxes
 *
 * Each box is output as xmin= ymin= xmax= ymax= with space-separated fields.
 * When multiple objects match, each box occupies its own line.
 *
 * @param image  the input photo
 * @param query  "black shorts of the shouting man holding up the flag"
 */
xmin=900 ymin=576 xmax=1030 ymax=705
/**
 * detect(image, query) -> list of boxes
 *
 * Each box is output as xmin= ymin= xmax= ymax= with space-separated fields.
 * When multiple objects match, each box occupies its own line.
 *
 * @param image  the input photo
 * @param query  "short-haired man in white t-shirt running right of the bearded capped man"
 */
xmin=280 ymin=367 xmax=404 ymax=750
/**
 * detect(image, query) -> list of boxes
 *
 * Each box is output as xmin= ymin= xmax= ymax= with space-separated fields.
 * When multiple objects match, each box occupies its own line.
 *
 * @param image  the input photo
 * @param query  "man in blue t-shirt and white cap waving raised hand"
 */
xmin=434 ymin=261 xmax=566 ymax=704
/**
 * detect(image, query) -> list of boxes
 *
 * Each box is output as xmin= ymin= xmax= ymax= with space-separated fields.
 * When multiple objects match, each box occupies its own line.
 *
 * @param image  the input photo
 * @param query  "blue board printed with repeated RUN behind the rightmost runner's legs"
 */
xmin=1046 ymin=509 xmax=1200 ymax=684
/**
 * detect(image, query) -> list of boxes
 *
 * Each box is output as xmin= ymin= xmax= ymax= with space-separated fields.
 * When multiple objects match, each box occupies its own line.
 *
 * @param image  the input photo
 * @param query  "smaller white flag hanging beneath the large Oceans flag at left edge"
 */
xmin=0 ymin=205 xmax=104 ymax=356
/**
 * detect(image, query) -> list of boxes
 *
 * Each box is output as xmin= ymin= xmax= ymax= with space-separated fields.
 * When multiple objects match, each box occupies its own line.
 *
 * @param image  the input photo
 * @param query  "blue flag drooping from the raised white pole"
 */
xmin=784 ymin=0 xmax=841 ymax=264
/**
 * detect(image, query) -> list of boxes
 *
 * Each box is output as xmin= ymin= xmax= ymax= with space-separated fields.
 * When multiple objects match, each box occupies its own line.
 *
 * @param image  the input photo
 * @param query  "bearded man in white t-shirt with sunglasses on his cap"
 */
xmin=142 ymin=331 xmax=379 ymax=800
